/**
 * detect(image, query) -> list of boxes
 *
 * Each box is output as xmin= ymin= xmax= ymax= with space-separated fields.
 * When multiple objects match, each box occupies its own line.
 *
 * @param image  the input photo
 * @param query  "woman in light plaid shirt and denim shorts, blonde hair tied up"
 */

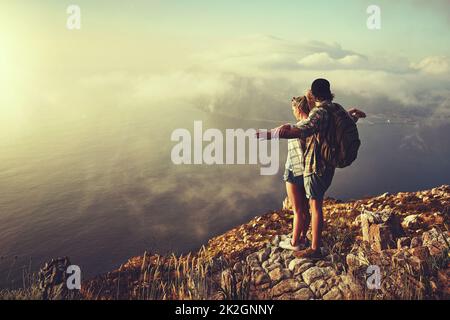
xmin=280 ymin=96 xmax=311 ymax=251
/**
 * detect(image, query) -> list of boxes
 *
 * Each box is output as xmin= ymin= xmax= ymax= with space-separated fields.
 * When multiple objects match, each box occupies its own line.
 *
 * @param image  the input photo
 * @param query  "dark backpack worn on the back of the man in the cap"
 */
xmin=320 ymin=103 xmax=361 ymax=168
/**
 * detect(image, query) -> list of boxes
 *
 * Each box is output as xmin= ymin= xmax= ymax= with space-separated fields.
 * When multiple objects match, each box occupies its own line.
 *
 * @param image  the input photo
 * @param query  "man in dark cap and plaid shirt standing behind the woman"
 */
xmin=262 ymin=79 xmax=365 ymax=259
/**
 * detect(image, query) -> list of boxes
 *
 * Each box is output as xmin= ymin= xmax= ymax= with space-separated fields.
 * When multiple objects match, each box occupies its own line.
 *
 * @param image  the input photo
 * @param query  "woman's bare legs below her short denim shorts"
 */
xmin=286 ymin=182 xmax=309 ymax=246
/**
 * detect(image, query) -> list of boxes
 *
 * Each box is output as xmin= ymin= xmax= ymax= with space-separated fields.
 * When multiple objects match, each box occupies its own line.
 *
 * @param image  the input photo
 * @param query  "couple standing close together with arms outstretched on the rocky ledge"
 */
xmin=260 ymin=79 xmax=366 ymax=259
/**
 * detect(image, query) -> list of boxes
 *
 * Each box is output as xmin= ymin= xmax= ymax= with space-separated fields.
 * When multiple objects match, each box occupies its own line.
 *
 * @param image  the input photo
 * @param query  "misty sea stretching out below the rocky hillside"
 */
xmin=0 ymin=108 xmax=450 ymax=287
